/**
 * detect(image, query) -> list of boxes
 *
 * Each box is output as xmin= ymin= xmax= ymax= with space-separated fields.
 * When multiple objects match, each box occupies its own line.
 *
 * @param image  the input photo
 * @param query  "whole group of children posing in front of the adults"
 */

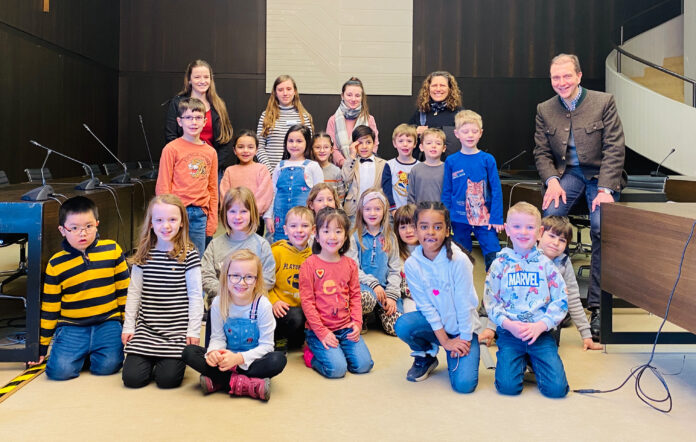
xmin=29 ymin=98 xmax=598 ymax=400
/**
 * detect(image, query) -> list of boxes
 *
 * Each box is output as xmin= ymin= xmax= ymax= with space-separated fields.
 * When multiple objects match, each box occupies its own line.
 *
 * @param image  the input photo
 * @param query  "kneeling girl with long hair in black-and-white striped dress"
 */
xmin=121 ymin=194 xmax=203 ymax=388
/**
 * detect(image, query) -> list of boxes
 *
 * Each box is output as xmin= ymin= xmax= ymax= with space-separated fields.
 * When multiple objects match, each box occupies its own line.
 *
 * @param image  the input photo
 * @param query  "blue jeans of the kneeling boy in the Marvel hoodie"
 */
xmin=495 ymin=327 xmax=568 ymax=398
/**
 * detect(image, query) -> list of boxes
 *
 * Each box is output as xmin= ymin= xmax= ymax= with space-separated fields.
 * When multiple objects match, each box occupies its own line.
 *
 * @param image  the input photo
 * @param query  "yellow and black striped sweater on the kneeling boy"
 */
xmin=40 ymin=238 xmax=130 ymax=356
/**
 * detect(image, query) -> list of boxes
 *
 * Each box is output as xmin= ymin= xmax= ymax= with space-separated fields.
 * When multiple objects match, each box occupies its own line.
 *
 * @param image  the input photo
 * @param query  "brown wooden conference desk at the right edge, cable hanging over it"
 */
xmin=600 ymin=203 xmax=696 ymax=344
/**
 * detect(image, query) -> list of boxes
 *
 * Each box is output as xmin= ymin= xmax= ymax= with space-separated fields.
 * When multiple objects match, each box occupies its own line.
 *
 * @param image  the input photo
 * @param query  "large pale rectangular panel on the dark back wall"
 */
xmin=266 ymin=0 xmax=413 ymax=95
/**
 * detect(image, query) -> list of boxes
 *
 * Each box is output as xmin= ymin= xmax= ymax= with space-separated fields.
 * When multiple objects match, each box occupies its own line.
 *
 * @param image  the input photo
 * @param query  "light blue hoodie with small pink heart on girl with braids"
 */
xmin=404 ymin=246 xmax=479 ymax=341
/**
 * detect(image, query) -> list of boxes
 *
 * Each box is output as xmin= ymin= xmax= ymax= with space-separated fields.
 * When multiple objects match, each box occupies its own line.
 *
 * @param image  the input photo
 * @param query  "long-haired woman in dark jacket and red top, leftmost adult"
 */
xmin=164 ymin=60 xmax=234 ymax=173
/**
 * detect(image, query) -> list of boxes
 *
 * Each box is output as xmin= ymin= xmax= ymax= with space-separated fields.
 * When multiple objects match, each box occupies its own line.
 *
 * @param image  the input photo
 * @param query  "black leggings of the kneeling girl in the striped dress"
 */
xmin=121 ymin=354 xmax=186 ymax=388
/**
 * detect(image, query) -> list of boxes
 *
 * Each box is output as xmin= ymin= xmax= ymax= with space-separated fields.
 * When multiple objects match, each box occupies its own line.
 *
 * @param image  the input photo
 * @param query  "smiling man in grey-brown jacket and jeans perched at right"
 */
xmin=534 ymin=54 xmax=625 ymax=340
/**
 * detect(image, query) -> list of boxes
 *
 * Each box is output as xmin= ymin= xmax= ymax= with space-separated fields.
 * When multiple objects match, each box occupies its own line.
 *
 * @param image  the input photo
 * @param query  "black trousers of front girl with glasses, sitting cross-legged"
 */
xmin=181 ymin=345 xmax=287 ymax=385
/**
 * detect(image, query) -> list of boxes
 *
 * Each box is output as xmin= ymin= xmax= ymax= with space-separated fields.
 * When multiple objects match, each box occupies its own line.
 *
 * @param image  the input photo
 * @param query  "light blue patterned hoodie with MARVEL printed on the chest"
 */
xmin=484 ymin=247 xmax=568 ymax=330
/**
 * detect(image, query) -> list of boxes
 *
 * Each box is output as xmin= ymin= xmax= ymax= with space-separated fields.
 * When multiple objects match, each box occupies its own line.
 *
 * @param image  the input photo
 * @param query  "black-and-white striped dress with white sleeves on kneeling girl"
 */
xmin=123 ymin=248 xmax=203 ymax=358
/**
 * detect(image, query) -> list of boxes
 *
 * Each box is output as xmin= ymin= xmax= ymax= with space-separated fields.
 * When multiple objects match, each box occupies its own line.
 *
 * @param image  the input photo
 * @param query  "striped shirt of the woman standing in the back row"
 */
xmin=256 ymin=106 xmax=312 ymax=173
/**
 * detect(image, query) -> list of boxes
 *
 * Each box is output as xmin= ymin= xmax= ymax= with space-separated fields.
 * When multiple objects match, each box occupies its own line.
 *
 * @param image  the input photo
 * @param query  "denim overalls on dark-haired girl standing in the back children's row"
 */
xmin=273 ymin=160 xmax=311 ymax=242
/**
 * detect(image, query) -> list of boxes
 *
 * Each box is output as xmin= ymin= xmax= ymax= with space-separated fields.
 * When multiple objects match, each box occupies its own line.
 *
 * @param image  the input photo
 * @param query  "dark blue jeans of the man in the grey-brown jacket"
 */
xmin=544 ymin=167 xmax=620 ymax=308
